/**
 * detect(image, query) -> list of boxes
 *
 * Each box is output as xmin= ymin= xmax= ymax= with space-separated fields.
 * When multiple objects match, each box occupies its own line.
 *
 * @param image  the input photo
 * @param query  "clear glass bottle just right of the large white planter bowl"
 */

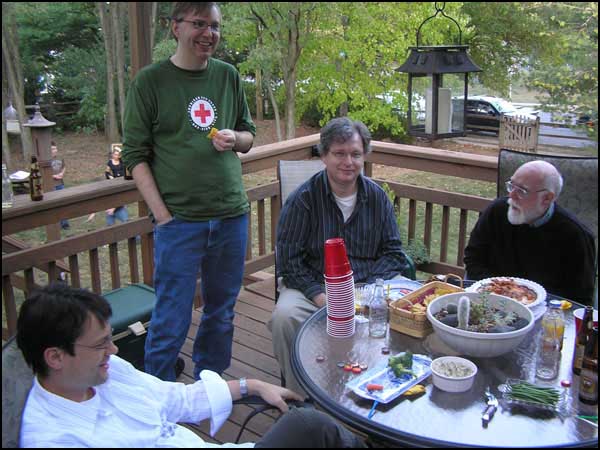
xmin=535 ymin=302 xmax=564 ymax=380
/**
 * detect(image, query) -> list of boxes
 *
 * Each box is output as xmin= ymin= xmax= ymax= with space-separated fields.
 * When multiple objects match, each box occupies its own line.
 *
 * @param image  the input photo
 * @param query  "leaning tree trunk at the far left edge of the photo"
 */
xmin=2 ymin=2 xmax=33 ymax=161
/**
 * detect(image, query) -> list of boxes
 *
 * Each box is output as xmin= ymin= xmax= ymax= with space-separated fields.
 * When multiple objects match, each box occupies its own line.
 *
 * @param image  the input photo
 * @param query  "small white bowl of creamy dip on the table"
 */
xmin=431 ymin=356 xmax=477 ymax=392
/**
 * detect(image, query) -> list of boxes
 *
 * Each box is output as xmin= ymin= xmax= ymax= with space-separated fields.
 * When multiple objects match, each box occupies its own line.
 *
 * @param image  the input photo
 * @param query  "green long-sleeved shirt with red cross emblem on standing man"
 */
xmin=122 ymin=58 xmax=256 ymax=221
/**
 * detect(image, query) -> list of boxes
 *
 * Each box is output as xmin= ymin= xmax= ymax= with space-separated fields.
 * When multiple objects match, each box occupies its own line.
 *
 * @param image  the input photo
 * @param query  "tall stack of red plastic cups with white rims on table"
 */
xmin=325 ymin=238 xmax=355 ymax=338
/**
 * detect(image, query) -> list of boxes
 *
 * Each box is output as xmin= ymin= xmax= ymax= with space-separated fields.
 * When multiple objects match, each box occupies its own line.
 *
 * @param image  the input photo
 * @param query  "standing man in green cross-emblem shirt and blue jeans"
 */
xmin=123 ymin=2 xmax=256 ymax=381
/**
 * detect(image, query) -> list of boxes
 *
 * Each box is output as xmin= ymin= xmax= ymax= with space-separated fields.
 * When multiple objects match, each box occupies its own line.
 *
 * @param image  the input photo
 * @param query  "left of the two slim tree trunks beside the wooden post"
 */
xmin=96 ymin=2 xmax=121 ymax=142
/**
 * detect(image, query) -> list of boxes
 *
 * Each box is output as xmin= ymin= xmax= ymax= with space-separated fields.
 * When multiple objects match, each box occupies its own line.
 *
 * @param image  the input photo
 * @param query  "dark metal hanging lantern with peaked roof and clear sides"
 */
xmin=396 ymin=2 xmax=481 ymax=140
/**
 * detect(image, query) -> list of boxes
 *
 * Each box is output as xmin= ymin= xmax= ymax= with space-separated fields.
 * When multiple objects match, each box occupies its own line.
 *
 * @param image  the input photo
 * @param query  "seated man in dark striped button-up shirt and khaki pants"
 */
xmin=268 ymin=117 xmax=410 ymax=393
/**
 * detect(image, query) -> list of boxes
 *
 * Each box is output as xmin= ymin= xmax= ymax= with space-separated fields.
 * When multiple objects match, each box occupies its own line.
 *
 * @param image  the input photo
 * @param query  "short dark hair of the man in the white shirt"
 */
xmin=17 ymin=283 xmax=112 ymax=377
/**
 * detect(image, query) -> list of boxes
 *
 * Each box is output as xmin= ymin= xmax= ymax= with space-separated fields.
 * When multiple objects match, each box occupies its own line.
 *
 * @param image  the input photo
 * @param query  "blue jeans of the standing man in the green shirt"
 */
xmin=145 ymin=214 xmax=248 ymax=381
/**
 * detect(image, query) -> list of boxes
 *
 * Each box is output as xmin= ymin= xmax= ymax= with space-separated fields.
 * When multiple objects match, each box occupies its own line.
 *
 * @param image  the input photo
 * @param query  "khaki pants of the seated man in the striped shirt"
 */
xmin=267 ymin=287 xmax=319 ymax=396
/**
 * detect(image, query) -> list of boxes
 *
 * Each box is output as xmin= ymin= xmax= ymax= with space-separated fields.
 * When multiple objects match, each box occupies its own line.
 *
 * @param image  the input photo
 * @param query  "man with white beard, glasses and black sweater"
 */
xmin=464 ymin=161 xmax=596 ymax=304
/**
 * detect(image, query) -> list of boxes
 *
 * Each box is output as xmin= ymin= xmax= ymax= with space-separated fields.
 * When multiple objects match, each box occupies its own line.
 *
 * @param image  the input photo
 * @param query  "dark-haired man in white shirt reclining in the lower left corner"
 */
xmin=17 ymin=283 xmax=365 ymax=448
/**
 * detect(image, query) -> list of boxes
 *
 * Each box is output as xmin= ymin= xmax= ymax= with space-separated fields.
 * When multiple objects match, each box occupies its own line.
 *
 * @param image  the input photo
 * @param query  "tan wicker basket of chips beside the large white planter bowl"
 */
xmin=390 ymin=274 xmax=464 ymax=338
